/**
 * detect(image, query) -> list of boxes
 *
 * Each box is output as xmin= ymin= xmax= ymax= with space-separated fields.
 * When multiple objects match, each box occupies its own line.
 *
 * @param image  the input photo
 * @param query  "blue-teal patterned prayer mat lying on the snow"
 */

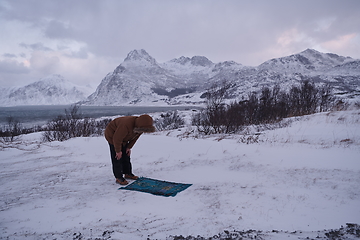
xmin=119 ymin=177 xmax=192 ymax=197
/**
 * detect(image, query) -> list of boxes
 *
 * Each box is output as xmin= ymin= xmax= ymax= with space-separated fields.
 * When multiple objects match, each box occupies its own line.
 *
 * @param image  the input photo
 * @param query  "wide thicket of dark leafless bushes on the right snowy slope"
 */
xmin=192 ymin=81 xmax=336 ymax=135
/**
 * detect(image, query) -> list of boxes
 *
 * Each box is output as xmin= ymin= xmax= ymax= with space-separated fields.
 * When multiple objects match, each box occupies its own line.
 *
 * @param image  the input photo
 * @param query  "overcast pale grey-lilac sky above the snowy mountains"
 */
xmin=0 ymin=0 xmax=360 ymax=88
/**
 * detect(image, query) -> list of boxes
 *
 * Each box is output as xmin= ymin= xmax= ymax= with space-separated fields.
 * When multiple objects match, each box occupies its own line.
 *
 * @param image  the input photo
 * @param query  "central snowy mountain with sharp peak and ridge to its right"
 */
xmin=82 ymin=50 xmax=248 ymax=105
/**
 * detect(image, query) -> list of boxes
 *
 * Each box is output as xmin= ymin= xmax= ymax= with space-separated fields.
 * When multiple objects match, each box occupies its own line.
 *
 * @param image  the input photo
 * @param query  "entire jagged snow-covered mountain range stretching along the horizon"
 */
xmin=2 ymin=49 xmax=360 ymax=106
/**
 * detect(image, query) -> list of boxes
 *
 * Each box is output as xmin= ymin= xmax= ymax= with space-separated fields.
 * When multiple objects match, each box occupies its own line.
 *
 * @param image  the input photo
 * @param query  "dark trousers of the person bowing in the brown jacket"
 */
xmin=109 ymin=143 xmax=132 ymax=179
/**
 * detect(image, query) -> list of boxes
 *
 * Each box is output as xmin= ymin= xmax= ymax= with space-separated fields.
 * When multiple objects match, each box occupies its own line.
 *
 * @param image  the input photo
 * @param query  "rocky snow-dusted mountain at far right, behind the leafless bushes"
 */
xmin=253 ymin=49 xmax=360 ymax=94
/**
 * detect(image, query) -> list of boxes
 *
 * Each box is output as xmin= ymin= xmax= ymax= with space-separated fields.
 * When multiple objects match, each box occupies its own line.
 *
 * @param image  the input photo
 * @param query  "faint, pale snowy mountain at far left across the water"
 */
xmin=0 ymin=74 xmax=91 ymax=106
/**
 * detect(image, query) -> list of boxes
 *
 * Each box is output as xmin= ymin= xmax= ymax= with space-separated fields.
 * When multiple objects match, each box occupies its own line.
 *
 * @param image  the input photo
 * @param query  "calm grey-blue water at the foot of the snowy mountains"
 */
xmin=0 ymin=106 xmax=200 ymax=127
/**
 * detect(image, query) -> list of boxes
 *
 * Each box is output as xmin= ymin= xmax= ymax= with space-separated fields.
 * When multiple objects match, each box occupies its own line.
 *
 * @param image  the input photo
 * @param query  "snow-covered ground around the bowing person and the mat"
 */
xmin=0 ymin=110 xmax=360 ymax=240
